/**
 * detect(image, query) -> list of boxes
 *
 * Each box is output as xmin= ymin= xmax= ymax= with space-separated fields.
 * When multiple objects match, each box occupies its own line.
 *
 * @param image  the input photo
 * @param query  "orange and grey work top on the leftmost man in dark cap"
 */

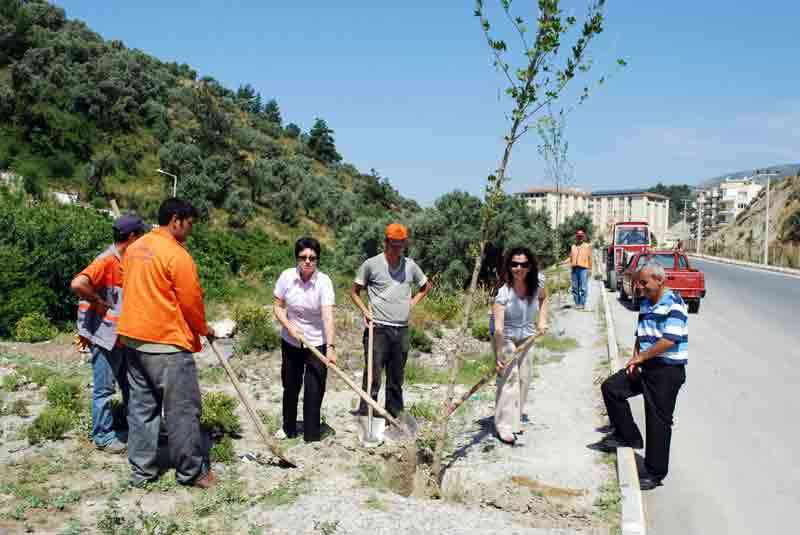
xmin=78 ymin=244 xmax=122 ymax=351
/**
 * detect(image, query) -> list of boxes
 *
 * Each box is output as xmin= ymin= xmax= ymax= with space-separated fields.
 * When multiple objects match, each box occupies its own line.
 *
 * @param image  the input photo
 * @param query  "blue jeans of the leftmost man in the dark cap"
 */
xmin=92 ymin=345 xmax=130 ymax=447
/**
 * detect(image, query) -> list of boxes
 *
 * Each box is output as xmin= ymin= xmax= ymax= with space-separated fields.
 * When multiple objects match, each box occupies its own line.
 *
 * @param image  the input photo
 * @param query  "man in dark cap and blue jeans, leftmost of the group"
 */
xmin=70 ymin=214 xmax=150 ymax=453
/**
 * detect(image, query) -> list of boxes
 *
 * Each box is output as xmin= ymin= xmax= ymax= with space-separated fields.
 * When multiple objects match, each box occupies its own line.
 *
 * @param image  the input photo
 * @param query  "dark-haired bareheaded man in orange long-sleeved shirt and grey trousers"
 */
xmin=118 ymin=198 xmax=214 ymax=488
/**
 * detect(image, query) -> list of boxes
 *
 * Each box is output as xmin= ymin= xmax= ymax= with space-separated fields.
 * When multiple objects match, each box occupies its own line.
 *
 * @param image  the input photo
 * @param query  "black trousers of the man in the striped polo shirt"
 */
xmin=600 ymin=362 xmax=686 ymax=479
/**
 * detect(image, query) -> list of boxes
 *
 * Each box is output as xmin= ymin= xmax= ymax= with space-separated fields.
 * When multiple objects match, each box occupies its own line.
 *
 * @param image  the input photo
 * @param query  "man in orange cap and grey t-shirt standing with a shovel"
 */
xmin=350 ymin=223 xmax=431 ymax=417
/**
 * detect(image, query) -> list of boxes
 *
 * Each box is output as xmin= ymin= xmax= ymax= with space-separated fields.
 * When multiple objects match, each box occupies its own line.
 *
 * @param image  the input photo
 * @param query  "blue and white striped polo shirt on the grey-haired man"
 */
xmin=636 ymin=288 xmax=689 ymax=366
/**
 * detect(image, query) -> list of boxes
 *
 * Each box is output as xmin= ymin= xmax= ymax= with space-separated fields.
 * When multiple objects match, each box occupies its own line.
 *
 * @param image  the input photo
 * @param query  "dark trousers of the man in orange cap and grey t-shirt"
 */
xmin=358 ymin=323 xmax=409 ymax=417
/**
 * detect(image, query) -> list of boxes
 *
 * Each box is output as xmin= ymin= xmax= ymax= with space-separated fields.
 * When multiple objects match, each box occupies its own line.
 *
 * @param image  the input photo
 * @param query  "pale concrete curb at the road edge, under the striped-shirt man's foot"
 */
xmin=600 ymin=256 xmax=647 ymax=535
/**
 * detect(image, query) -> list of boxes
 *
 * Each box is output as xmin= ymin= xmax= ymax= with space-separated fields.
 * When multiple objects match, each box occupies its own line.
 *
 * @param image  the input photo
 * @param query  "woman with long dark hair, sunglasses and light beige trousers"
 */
xmin=492 ymin=247 xmax=547 ymax=445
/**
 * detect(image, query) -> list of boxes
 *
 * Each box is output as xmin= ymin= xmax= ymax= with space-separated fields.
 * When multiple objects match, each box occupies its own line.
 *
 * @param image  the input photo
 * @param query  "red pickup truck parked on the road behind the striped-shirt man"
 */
xmin=619 ymin=249 xmax=706 ymax=314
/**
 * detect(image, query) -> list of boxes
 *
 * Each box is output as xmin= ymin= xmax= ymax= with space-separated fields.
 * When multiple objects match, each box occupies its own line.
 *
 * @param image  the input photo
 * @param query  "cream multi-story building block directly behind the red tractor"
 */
xmin=589 ymin=189 xmax=669 ymax=240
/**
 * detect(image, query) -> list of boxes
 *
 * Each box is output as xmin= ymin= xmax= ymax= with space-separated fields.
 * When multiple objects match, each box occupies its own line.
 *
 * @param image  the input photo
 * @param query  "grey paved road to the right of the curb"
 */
xmin=613 ymin=261 xmax=800 ymax=535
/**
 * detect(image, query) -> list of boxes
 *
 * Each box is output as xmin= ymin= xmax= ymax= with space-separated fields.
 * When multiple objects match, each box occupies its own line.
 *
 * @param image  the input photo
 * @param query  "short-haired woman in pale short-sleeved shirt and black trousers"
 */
xmin=273 ymin=238 xmax=336 ymax=442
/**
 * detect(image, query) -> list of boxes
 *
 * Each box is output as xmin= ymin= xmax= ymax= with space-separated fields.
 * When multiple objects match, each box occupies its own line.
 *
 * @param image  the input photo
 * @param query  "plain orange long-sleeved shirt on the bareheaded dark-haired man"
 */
xmin=117 ymin=228 xmax=209 ymax=353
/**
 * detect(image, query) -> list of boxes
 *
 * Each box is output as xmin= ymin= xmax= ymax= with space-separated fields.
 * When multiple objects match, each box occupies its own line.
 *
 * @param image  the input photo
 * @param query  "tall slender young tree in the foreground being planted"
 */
xmin=431 ymin=0 xmax=624 ymax=491
